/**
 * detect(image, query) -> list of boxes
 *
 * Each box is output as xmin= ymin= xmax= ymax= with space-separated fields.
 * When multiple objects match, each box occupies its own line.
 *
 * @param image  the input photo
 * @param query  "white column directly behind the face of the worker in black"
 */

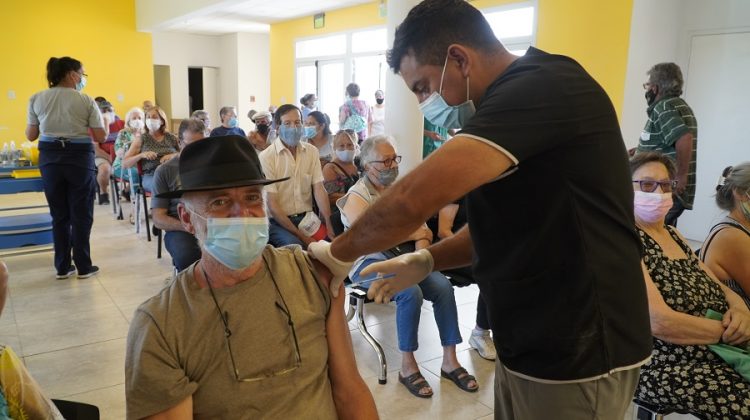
xmin=385 ymin=0 xmax=424 ymax=175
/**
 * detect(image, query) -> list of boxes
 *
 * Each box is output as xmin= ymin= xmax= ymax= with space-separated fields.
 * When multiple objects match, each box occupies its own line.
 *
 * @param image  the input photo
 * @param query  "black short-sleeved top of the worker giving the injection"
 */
xmin=461 ymin=48 xmax=652 ymax=381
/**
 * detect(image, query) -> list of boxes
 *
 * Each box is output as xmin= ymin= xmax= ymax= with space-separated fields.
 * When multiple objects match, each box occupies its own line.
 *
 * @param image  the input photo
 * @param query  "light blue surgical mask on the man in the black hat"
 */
xmin=188 ymin=209 xmax=268 ymax=270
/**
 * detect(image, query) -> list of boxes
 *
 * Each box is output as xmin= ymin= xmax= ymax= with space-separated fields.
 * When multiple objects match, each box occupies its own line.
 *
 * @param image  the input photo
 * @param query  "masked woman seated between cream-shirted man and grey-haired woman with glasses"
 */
xmin=323 ymin=130 xmax=359 ymax=205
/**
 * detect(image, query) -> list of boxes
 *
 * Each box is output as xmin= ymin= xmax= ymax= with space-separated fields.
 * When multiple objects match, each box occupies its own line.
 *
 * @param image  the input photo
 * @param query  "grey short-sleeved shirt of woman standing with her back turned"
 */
xmin=27 ymin=87 xmax=104 ymax=138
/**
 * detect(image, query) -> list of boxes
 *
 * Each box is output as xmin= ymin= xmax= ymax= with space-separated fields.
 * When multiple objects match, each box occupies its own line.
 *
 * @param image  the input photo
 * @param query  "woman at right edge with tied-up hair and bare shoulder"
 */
xmin=700 ymin=162 xmax=750 ymax=308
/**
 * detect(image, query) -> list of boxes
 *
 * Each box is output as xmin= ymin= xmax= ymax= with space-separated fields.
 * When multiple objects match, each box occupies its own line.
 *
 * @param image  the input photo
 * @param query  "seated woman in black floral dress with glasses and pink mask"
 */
xmin=630 ymin=152 xmax=750 ymax=418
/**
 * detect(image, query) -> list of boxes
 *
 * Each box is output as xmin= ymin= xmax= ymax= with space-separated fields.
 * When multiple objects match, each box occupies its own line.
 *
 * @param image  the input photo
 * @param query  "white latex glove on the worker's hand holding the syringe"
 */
xmin=359 ymin=249 xmax=435 ymax=303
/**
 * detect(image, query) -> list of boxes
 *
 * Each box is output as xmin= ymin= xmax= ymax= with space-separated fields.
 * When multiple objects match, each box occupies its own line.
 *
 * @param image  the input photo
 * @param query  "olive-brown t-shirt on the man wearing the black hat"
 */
xmin=125 ymin=246 xmax=336 ymax=419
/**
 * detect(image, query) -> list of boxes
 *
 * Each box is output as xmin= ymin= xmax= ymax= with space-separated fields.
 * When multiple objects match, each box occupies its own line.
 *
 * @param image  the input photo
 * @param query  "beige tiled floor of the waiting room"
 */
xmin=0 ymin=199 xmax=687 ymax=420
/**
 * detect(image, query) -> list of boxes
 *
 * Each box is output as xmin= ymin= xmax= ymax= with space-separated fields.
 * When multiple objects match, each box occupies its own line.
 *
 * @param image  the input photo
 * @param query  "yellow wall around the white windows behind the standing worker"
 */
xmin=271 ymin=0 xmax=633 ymax=114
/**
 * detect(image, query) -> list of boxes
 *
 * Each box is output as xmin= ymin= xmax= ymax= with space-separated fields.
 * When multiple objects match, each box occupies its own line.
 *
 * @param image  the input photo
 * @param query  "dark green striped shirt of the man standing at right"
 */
xmin=638 ymin=96 xmax=698 ymax=210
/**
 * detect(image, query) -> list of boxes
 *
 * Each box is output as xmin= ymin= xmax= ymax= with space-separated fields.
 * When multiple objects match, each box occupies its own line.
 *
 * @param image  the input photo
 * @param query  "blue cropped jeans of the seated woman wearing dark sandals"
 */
xmin=351 ymin=258 xmax=462 ymax=352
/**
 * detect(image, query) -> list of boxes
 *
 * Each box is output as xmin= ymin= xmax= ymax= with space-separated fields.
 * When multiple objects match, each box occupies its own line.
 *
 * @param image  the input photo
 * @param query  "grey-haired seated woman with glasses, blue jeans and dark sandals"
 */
xmin=336 ymin=136 xmax=479 ymax=398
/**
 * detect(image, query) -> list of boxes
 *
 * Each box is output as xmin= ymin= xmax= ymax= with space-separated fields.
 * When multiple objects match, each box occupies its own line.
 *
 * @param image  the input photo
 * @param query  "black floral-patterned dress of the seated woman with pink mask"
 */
xmin=635 ymin=226 xmax=750 ymax=419
